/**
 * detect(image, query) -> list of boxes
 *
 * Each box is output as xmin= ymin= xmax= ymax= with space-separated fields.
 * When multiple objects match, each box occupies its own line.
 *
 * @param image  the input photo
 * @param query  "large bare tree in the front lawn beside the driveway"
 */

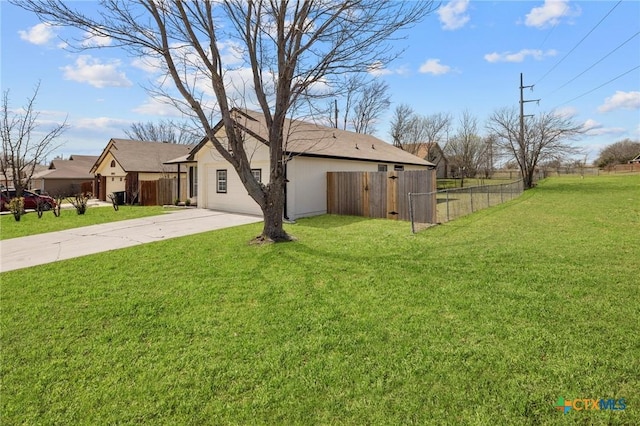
xmin=14 ymin=0 xmax=435 ymax=241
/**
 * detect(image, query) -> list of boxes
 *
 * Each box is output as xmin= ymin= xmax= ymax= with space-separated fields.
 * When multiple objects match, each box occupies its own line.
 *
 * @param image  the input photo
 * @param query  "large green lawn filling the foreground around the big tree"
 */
xmin=0 ymin=176 xmax=640 ymax=425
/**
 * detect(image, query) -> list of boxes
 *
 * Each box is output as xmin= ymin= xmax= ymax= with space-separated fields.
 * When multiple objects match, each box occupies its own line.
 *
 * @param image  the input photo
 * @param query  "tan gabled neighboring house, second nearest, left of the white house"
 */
xmin=91 ymin=139 xmax=194 ymax=202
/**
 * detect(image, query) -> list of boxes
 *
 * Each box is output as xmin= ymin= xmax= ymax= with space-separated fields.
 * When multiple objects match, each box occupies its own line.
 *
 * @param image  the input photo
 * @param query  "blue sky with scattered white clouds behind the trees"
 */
xmin=0 ymin=0 xmax=640 ymax=161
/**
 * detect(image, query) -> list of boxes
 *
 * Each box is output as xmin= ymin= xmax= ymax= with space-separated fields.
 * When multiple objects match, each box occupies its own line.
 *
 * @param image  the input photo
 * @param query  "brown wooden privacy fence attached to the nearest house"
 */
xmin=327 ymin=170 xmax=437 ymax=223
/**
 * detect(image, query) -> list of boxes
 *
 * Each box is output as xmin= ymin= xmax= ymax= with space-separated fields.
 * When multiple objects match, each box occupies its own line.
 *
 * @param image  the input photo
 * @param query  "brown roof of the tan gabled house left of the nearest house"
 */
xmin=91 ymin=139 xmax=195 ymax=173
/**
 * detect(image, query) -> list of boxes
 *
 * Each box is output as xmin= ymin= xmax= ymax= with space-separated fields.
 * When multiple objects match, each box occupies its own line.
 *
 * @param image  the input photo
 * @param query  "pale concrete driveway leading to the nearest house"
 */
xmin=0 ymin=209 xmax=262 ymax=272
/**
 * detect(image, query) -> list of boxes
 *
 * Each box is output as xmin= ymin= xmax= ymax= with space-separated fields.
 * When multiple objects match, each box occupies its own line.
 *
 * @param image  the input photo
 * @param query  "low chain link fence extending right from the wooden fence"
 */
xmin=408 ymin=179 xmax=524 ymax=234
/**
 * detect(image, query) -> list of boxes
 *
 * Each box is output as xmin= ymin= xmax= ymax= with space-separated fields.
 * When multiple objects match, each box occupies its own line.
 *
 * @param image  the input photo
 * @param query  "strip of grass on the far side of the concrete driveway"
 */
xmin=0 ymin=206 xmax=166 ymax=240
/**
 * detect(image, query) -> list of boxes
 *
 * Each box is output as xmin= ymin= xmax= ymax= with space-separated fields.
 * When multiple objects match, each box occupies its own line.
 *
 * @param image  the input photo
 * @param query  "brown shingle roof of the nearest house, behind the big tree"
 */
xmin=191 ymin=109 xmax=434 ymax=166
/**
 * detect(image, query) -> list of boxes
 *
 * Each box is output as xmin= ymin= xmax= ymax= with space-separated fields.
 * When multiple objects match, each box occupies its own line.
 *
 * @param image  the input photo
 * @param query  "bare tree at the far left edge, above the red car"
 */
xmin=0 ymin=83 xmax=68 ymax=197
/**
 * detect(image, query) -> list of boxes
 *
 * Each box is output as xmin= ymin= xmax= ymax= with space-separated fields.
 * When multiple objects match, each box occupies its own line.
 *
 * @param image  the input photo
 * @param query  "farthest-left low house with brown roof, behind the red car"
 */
xmin=31 ymin=155 xmax=98 ymax=196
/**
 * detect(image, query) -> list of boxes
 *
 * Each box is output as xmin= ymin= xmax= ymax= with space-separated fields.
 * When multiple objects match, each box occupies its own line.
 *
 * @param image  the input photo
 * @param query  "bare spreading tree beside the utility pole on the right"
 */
xmin=487 ymin=108 xmax=584 ymax=188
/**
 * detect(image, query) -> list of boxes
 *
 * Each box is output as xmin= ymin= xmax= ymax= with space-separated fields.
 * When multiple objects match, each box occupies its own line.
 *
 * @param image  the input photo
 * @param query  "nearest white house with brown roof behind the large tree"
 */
xmin=187 ymin=109 xmax=434 ymax=220
